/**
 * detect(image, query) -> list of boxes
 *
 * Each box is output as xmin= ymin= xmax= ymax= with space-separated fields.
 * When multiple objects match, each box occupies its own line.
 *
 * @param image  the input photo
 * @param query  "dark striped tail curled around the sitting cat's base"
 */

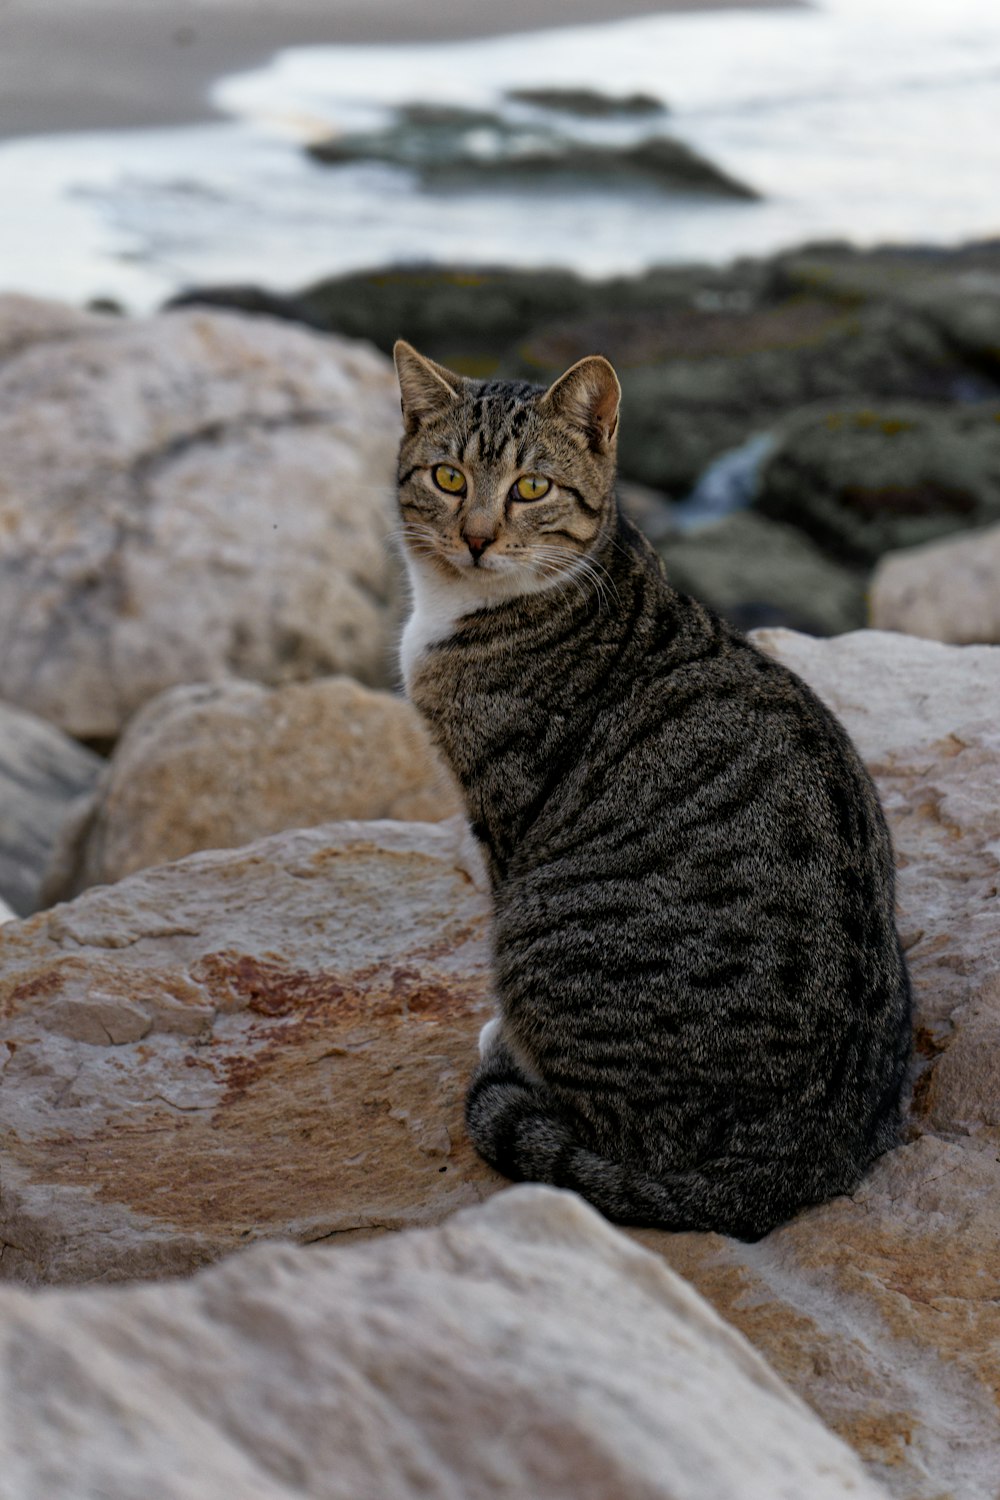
xmin=465 ymin=1046 xmax=811 ymax=1241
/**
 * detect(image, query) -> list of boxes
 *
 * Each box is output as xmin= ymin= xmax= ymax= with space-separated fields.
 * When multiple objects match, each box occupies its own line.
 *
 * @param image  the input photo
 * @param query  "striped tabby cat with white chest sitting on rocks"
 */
xmin=394 ymin=341 xmax=910 ymax=1241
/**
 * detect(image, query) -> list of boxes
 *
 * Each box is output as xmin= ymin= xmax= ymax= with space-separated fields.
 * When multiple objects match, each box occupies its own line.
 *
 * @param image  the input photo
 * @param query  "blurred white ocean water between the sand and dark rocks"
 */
xmin=0 ymin=0 xmax=1000 ymax=311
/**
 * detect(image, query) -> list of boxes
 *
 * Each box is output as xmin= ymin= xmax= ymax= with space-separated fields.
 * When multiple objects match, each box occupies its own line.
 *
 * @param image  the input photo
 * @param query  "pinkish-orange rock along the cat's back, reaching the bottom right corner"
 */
xmin=639 ymin=630 xmax=1000 ymax=1500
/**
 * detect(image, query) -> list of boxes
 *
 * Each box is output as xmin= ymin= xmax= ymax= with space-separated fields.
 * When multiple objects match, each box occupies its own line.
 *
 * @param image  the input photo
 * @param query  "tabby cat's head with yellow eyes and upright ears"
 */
xmin=394 ymin=339 xmax=621 ymax=597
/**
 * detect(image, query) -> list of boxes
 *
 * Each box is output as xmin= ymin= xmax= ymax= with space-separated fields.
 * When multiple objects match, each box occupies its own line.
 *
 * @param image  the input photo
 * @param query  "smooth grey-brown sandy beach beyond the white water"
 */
xmin=0 ymin=0 xmax=799 ymax=138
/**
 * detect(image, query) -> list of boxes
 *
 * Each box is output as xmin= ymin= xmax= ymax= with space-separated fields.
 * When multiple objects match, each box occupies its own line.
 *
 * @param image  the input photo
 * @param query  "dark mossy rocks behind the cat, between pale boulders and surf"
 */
xmin=178 ymin=243 xmax=1000 ymax=641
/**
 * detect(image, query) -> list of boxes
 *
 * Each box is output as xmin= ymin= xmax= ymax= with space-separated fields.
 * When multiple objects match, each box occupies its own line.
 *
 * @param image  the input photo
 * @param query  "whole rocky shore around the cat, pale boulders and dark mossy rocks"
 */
xmin=0 ymin=264 xmax=1000 ymax=1500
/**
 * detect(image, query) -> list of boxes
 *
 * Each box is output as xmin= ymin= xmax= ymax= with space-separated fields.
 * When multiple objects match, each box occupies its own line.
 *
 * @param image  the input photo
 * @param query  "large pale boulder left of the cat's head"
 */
xmin=0 ymin=303 xmax=399 ymax=740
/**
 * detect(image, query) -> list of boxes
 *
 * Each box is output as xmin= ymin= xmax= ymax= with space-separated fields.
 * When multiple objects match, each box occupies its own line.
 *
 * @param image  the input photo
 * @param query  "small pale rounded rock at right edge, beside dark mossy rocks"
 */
xmin=871 ymin=527 xmax=1000 ymax=645
